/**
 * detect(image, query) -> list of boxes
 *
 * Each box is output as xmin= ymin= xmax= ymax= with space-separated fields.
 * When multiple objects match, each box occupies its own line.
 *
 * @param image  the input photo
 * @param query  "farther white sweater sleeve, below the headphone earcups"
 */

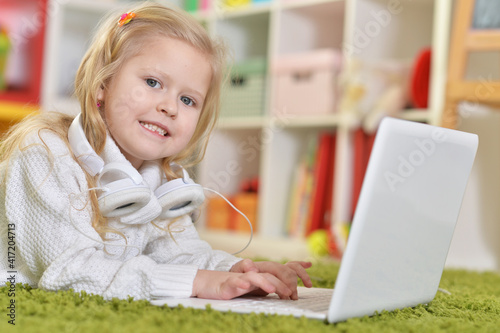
xmin=144 ymin=216 xmax=242 ymax=271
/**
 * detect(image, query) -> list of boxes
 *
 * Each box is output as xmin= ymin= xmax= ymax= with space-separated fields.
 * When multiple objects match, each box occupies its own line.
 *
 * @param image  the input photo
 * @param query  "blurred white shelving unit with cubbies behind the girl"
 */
xmin=42 ymin=0 xmax=452 ymax=259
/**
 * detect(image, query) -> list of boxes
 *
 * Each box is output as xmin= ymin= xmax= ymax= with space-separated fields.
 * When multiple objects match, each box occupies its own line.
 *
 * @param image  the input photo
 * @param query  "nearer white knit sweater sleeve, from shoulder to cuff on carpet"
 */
xmin=0 ymin=132 xmax=198 ymax=299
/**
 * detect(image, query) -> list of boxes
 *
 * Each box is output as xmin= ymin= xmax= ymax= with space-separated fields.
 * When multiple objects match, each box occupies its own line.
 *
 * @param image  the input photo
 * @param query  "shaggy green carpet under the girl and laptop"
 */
xmin=0 ymin=263 xmax=500 ymax=333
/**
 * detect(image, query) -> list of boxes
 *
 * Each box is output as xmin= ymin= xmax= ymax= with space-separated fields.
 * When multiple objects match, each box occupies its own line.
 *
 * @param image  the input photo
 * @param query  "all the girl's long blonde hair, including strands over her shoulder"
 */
xmin=0 ymin=1 xmax=226 ymax=238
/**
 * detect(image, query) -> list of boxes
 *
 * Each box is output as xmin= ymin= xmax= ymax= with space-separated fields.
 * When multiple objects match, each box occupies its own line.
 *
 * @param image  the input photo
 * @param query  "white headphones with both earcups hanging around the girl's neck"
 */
xmin=68 ymin=114 xmax=205 ymax=218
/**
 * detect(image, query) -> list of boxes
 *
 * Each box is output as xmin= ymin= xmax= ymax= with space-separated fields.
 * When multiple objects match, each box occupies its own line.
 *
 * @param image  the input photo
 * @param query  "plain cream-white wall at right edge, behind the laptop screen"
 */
xmin=446 ymin=103 xmax=500 ymax=271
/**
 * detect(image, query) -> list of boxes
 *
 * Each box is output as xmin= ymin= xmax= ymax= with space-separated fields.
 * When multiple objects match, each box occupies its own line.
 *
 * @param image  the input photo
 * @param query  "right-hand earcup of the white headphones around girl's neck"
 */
xmin=155 ymin=178 xmax=205 ymax=218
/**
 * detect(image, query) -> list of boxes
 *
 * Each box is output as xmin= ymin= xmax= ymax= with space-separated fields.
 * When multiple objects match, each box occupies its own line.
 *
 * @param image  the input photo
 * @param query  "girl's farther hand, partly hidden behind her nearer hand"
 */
xmin=230 ymin=259 xmax=312 ymax=300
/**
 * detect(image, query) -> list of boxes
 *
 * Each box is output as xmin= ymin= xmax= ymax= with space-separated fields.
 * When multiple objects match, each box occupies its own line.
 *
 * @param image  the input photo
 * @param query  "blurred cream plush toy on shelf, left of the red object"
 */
xmin=339 ymin=59 xmax=410 ymax=133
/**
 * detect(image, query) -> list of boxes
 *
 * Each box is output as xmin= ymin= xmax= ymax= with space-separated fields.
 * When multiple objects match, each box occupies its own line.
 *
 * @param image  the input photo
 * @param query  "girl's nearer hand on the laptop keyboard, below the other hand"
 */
xmin=192 ymin=270 xmax=297 ymax=300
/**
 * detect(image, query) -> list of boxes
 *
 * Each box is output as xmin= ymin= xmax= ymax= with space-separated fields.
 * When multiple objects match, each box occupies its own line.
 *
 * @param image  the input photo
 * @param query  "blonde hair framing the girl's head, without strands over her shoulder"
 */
xmin=75 ymin=2 xmax=226 ymax=177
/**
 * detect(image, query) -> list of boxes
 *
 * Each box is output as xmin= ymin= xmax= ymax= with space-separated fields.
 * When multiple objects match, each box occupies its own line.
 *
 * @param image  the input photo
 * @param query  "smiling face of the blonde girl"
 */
xmin=97 ymin=37 xmax=212 ymax=168
